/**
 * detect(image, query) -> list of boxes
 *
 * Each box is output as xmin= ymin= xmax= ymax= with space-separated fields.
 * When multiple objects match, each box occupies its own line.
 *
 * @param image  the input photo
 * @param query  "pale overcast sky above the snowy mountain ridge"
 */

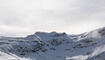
xmin=0 ymin=0 xmax=105 ymax=36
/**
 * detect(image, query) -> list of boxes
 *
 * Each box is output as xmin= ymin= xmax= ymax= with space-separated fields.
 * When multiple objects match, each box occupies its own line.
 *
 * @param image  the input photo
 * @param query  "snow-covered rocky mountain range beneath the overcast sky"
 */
xmin=0 ymin=28 xmax=105 ymax=60
